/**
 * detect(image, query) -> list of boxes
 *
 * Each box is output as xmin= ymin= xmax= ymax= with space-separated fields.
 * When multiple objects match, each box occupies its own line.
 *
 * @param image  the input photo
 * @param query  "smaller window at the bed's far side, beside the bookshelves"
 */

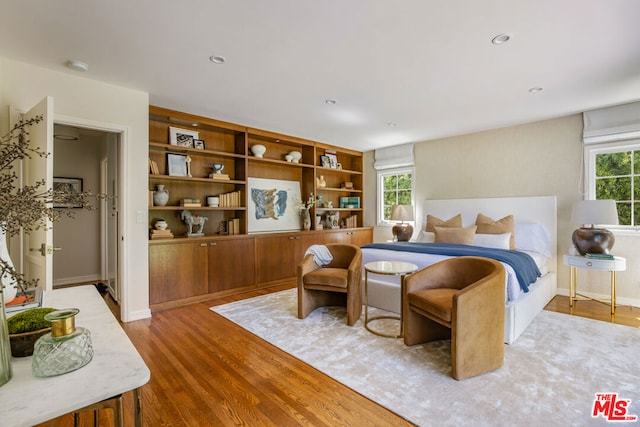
xmin=378 ymin=169 xmax=414 ymax=225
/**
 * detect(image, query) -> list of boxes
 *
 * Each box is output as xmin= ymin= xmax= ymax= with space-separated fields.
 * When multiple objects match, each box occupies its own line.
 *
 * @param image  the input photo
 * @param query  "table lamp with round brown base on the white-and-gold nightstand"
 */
xmin=571 ymin=200 xmax=618 ymax=255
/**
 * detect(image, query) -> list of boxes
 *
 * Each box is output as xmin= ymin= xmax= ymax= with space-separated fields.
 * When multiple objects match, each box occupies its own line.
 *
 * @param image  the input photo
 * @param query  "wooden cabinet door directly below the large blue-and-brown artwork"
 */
xmin=256 ymin=236 xmax=296 ymax=283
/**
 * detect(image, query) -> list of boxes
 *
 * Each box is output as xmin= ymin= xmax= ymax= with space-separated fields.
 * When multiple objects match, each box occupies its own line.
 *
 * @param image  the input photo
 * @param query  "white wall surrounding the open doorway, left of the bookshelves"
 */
xmin=0 ymin=57 xmax=150 ymax=321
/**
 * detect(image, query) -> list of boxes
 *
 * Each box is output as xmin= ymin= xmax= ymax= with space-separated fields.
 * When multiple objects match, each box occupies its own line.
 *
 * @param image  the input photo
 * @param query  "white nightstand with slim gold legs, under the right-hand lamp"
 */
xmin=562 ymin=255 xmax=627 ymax=314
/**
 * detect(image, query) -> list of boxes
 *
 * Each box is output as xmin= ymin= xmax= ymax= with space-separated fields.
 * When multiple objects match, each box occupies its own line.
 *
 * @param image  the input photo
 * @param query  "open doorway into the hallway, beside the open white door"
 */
xmin=53 ymin=123 xmax=121 ymax=303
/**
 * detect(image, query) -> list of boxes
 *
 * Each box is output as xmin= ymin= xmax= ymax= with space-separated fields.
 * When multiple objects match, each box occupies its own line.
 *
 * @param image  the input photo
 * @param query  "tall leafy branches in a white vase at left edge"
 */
xmin=0 ymin=116 xmax=104 ymax=385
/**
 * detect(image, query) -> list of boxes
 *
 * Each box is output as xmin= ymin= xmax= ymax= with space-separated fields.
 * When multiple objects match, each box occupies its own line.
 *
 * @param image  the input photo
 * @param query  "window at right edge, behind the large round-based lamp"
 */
xmin=585 ymin=140 xmax=640 ymax=228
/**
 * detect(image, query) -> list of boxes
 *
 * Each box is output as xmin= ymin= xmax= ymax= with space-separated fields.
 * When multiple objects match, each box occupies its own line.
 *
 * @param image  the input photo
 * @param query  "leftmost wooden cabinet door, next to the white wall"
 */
xmin=149 ymin=243 xmax=208 ymax=304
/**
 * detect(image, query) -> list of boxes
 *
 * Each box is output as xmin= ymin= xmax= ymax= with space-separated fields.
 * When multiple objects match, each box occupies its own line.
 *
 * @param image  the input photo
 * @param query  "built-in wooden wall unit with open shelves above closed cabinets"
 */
xmin=149 ymin=106 xmax=373 ymax=310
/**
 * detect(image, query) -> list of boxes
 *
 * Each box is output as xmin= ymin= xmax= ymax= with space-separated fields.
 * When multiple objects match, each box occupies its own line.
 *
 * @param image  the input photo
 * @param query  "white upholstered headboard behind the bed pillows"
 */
xmin=420 ymin=196 xmax=558 ymax=271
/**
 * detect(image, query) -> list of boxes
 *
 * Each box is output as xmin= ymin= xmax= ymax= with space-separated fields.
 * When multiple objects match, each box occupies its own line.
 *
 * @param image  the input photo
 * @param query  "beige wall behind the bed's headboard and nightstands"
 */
xmin=365 ymin=114 xmax=640 ymax=306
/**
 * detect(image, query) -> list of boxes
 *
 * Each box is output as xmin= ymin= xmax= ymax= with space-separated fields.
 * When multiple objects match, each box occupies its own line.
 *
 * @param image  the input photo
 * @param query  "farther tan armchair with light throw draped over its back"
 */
xmin=297 ymin=243 xmax=362 ymax=326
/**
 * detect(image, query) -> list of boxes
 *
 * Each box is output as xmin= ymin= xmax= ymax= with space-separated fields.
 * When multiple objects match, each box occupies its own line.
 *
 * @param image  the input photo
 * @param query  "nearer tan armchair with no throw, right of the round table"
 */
xmin=402 ymin=257 xmax=505 ymax=380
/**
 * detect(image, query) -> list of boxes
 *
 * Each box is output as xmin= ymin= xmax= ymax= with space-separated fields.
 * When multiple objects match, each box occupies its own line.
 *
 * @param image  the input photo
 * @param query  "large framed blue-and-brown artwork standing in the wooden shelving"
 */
xmin=247 ymin=177 xmax=302 ymax=233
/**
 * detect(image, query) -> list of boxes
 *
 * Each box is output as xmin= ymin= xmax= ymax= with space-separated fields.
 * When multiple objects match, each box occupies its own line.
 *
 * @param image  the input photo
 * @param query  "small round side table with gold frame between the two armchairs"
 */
xmin=364 ymin=261 xmax=418 ymax=338
